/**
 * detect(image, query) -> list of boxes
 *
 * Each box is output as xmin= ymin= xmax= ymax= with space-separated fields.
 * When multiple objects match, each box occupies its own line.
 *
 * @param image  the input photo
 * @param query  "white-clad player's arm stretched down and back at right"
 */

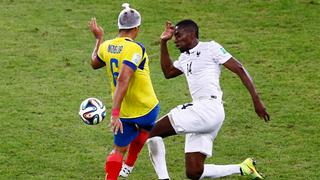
xmin=223 ymin=57 xmax=270 ymax=122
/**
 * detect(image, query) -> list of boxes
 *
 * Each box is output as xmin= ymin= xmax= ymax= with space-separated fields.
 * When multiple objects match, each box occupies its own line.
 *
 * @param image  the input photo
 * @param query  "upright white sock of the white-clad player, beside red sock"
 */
xmin=147 ymin=136 xmax=169 ymax=179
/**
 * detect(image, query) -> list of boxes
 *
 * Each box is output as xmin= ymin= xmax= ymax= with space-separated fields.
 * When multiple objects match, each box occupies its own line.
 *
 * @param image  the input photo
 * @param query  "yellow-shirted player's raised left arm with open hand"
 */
xmin=88 ymin=18 xmax=105 ymax=69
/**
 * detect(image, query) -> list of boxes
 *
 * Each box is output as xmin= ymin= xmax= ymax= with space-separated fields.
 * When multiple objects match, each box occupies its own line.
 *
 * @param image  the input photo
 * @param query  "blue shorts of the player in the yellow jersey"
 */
xmin=114 ymin=104 xmax=160 ymax=147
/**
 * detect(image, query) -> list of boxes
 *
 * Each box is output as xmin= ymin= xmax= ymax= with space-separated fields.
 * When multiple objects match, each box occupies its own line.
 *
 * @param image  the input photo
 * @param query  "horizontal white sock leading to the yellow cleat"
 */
xmin=200 ymin=164 xmax=241 ymax=179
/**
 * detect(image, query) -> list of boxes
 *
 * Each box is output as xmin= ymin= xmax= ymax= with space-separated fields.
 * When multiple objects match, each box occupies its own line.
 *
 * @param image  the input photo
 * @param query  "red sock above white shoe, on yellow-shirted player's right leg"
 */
xmin=126 ymin=131 xmax=149 ymax=167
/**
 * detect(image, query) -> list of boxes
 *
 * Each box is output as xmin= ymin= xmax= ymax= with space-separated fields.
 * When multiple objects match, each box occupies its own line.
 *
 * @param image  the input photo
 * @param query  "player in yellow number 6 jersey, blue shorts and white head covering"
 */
xmin=89 ymin=3 xmax=159 ymax=180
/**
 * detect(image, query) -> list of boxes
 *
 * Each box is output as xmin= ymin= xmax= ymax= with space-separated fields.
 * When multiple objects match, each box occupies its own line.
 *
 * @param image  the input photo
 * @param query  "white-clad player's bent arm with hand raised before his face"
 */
xmin=160 ymin=22 xmax=182 ymax=79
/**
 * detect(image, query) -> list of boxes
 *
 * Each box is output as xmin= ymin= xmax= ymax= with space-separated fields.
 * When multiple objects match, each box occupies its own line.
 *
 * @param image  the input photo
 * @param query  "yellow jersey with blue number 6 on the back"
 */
xmin=98 ymin=37 xmax=159 ymax=118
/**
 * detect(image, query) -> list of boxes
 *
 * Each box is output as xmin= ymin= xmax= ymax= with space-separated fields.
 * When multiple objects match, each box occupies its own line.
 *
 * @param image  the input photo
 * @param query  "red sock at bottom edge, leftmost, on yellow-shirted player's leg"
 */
xmin=105 ymin=152 xmax=123 ymax=180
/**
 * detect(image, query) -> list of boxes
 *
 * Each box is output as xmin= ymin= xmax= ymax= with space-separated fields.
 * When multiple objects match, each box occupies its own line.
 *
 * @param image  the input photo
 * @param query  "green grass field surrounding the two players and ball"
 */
xmin=0 ymin=0 xmax=320 ymax=180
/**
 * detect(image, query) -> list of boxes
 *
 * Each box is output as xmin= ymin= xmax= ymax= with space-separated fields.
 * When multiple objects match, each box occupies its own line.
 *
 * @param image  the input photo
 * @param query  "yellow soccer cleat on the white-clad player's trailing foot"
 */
xmin=240 ymin=158 xmax=263 ymax=179
